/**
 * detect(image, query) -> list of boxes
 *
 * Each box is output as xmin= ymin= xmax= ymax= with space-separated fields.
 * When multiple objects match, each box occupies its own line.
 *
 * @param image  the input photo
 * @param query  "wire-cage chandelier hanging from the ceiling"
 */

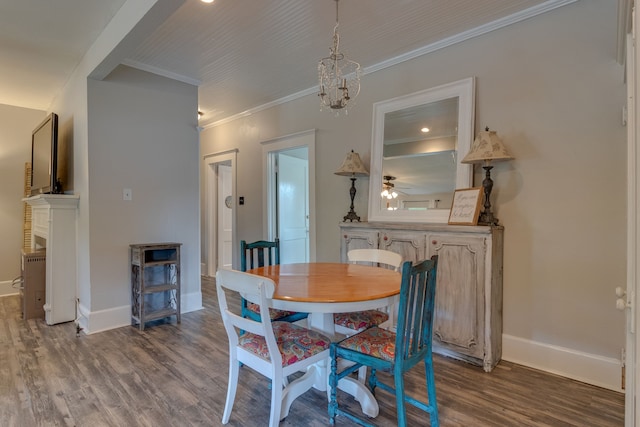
xmin=318 ymin=0 xmax=361 ymax=115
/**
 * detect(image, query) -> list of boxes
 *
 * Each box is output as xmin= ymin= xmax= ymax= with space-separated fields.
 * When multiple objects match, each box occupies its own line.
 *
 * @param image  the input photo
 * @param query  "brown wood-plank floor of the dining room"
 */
xmin=0 ymin=279 xmax=624 ymax=427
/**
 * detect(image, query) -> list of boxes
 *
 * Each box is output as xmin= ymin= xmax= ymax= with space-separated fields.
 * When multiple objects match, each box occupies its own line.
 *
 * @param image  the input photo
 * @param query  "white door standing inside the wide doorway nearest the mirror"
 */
xmin=276 ymin=147 xmax=309 ymax=264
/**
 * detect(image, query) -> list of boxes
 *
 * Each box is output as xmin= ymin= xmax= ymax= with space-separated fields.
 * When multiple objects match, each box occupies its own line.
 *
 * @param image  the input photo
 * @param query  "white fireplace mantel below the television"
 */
xmin=23 ymin=194 xmax=79 ymax=325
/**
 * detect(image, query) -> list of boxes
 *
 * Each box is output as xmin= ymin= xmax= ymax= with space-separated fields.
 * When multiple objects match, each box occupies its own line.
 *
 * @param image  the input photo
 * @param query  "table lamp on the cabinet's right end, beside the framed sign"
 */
xmin=462 ymin=127 xmax=513 ymax=225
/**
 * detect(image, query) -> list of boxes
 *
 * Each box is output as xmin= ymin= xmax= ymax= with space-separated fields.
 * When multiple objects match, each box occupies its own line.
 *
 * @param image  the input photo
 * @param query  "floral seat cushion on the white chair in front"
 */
xmin=238 ymin=322 xmax=331 ymax=367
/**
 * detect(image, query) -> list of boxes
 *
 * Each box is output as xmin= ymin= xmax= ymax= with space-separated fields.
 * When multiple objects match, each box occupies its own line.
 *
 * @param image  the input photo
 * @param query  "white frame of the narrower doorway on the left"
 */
xmin=203 ymin=148 xmax=238 ymax=277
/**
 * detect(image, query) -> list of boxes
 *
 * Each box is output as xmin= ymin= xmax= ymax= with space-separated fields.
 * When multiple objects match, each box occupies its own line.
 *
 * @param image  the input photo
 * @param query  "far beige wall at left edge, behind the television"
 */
xmin=0 ymin=104 xmax=46 ymax=295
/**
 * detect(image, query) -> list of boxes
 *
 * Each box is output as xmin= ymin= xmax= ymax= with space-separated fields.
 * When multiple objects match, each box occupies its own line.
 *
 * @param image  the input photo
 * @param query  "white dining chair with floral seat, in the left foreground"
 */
xmin=216 ymin=269 xmax=331 ymax=427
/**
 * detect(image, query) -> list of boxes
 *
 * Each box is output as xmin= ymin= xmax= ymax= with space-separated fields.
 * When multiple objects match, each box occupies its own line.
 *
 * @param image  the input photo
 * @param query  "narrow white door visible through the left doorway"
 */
xmin=217 ymin=163 xmax=233 ymax=268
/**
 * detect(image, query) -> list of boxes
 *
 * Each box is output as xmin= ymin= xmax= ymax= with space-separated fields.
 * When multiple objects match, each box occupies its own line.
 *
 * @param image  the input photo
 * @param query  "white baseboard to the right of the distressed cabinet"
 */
xmin=502 ymin=334 xmax=624 ymax=392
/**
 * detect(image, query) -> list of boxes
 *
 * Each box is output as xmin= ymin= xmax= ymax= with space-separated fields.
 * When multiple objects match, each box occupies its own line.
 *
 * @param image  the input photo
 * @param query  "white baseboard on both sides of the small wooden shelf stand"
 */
xmin=78 ymin=291 xmax=203 ymax=334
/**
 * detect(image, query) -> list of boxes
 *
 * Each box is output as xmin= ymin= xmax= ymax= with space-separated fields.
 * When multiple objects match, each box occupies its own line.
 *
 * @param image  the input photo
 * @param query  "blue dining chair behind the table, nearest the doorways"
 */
xmin=240 ymin=238 xmax=309 ymax=322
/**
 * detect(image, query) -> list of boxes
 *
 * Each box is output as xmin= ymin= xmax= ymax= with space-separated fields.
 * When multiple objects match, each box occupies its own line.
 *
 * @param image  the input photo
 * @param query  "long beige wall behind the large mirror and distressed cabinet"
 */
xmin=201 ymin=0 xmax=626 ymax=389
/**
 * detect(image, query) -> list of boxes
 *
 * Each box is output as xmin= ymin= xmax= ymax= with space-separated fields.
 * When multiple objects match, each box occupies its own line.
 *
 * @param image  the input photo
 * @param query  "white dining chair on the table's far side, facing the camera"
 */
xmin=333 ymin=249 xmax=402 ymax=336
